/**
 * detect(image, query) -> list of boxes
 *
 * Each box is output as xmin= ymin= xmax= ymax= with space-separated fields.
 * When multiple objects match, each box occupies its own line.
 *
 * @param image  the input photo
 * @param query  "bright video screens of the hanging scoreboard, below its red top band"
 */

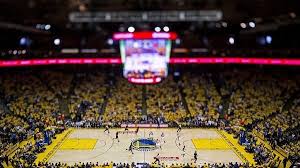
xmin=120 ymin=39 xmax=171 ymax=84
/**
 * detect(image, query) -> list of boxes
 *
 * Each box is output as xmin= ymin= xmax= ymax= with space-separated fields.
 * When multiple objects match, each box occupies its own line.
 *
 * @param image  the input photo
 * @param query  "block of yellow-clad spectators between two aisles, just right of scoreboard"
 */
xmin=183 ymin=73 xmax=223 ymax=127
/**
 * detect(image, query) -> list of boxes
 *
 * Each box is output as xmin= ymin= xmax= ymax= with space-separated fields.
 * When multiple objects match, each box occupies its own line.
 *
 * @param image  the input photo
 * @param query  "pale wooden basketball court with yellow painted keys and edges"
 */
xmin=34 ymin=128 xmax=253 ymax=165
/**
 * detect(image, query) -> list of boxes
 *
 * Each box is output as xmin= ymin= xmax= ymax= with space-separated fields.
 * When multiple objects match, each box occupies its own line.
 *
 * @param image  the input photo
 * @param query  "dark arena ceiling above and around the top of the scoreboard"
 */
xmin=0 ymin=0 xmax=300 ymax=57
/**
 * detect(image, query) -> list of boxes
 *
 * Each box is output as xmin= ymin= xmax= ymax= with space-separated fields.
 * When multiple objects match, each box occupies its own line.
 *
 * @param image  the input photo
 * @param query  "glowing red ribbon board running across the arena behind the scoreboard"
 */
xmin=0 ymin=57 xmax=300 ymax=67
